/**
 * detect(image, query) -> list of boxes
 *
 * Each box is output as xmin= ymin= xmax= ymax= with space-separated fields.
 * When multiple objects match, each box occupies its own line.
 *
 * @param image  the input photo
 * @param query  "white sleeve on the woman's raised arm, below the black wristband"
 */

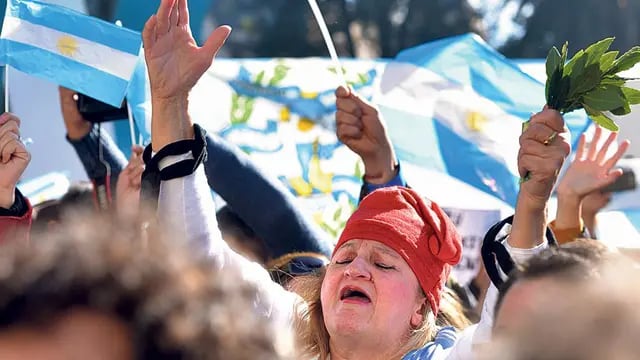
xmin=158 ymin=160 xmax=302 ymax=329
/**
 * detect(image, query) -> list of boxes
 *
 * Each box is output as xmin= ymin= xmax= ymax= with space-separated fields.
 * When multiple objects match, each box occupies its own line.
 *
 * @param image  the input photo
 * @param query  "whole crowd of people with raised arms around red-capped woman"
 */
xmin=0 ymin=0 xmax=640 ymax=360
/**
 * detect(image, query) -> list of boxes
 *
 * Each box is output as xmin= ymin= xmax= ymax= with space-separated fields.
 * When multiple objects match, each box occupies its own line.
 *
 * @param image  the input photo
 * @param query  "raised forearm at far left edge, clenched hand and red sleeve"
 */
xmin=0 ymin=113 xmax=32 ymax=243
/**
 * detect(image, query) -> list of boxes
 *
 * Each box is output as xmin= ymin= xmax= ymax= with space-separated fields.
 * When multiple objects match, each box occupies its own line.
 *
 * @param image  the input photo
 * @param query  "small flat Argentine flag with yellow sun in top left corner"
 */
xmin=0 ymin=0 xmax=142 ymax=107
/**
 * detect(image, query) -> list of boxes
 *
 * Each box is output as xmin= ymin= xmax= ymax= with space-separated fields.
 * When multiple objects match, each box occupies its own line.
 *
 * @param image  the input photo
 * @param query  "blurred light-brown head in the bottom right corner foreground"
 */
xmin=481 ymin=261 xmax=640 ymax=360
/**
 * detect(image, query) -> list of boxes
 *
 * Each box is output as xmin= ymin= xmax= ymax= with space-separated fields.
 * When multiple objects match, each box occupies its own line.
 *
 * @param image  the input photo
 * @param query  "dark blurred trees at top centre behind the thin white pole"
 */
xmin=213 ymin=0 xmax=482 ymax=57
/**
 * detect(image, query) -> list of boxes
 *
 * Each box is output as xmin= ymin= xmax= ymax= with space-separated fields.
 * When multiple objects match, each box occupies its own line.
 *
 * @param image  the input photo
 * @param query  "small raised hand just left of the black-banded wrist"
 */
xmin=116 ymin=145 xmax=144 ymax=220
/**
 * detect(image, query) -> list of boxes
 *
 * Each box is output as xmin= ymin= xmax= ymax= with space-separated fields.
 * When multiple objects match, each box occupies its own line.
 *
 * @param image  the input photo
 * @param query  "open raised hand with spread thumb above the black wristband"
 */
xmin=142 ymin=0 xmax=231 ymax=152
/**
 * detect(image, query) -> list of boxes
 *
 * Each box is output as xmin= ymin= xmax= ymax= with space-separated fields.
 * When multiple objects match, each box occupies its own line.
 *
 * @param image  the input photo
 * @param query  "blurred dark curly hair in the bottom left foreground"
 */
xmin=0 ymin=221 xmax=290 ymax=360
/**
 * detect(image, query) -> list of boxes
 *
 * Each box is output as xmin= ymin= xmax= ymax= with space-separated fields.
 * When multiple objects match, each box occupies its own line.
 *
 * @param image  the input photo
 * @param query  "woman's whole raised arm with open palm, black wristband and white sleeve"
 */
xmin=142 ymin=0 xmax=297 ymax=325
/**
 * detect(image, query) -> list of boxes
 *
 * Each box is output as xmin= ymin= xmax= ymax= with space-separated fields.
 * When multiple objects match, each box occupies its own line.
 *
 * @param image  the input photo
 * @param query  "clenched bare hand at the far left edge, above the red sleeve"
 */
xmin=0 ymin=113 xmax=31 ymax=209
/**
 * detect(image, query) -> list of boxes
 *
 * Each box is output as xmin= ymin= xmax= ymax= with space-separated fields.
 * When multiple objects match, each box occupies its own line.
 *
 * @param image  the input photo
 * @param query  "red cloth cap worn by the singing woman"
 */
xmin=334 ymin=187 xmax=462 ymax=314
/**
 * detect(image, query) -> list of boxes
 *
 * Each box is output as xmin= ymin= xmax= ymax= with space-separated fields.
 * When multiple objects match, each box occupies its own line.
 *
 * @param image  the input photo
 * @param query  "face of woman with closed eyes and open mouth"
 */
xmin=320 ymin=239 xmax=428 ymax=344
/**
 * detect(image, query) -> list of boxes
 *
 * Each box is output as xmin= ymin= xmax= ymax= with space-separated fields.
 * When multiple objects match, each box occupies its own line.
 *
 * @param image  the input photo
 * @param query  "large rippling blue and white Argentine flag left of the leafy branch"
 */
xmin=377 ymin=35 xmax=590 ymax=206
